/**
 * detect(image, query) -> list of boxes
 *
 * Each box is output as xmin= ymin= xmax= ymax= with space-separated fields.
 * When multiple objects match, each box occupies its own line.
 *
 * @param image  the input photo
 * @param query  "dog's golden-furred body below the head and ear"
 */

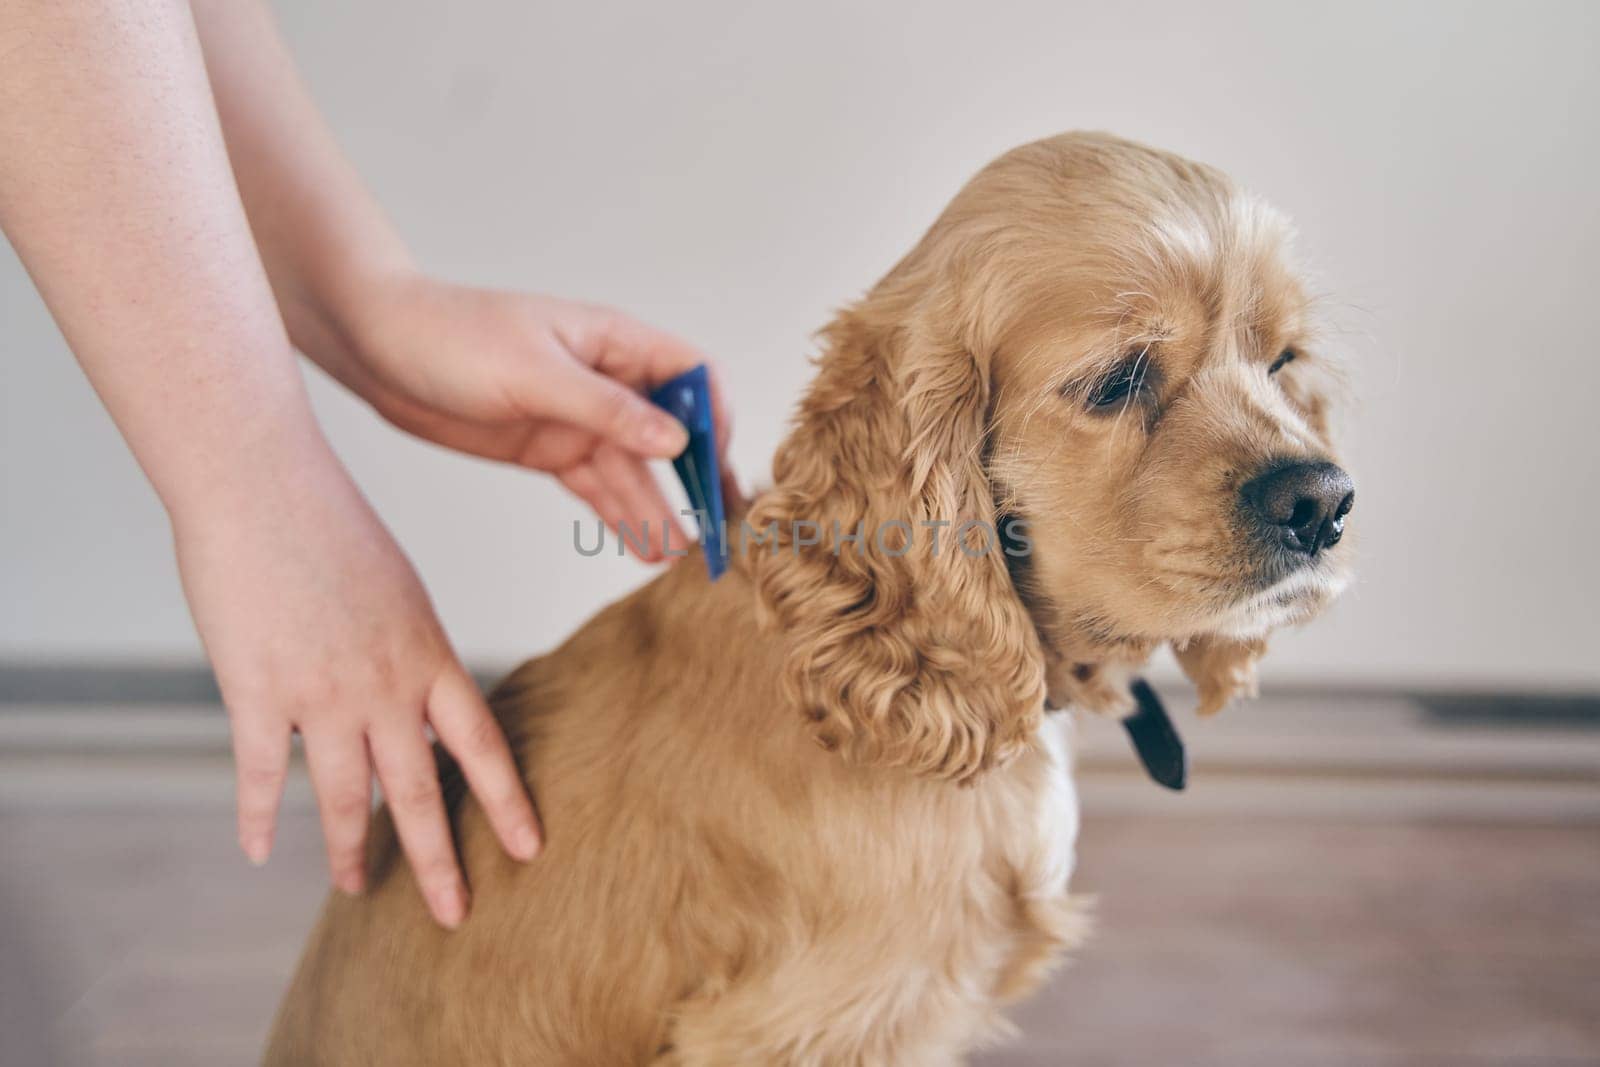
xmin=267 ymin=561 xmax=1075 ymax=1067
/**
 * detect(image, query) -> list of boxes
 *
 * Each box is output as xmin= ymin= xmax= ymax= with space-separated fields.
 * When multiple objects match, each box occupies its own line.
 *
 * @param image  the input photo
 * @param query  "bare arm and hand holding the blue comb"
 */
xmin=194 ymin=0 xmax=728 ymax=560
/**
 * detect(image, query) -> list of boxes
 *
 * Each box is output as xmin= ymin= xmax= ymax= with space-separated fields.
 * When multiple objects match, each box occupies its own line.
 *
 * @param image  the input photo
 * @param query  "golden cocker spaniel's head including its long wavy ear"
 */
xmin=750 ymin=134 xmax=1354 ymax=779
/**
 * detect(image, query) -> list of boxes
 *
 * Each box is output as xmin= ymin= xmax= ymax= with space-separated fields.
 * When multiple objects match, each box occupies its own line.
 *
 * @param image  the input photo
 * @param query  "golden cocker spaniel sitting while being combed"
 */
xmin=266 ymin=133 xmax=1354 ymax=1067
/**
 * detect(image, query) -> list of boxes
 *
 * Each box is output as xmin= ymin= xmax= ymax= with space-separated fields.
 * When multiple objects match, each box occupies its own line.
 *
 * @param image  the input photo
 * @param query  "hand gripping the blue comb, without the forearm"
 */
xmin=330 ymin=274 xmax=731 ymax=561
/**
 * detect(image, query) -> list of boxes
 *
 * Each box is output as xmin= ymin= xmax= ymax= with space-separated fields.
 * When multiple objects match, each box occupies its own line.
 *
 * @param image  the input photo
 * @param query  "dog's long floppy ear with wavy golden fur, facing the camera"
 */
xmin=744 ymin=253 xmax=1043 ymax=781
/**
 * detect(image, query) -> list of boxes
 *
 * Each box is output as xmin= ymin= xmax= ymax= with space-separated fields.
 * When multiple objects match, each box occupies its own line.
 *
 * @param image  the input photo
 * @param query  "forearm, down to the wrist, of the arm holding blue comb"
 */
xmin=192 ymin=0 xmax=413 ymax=400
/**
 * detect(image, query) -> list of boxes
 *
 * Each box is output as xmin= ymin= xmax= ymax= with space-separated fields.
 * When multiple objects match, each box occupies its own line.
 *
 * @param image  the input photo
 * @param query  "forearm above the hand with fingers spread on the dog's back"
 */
xmin=0 ymin=0 xmax=325 ymax=514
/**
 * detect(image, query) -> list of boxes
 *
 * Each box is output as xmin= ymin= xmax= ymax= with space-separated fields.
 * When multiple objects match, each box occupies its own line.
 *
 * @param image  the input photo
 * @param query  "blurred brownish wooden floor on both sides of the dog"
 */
xmin=0 ymin=813 xmax=1600 ymax=1067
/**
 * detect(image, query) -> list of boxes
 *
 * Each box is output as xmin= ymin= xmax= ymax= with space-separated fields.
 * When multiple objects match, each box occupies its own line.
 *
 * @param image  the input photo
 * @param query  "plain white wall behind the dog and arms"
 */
xmin=0 ymin=0 xmax=1600 ymax=686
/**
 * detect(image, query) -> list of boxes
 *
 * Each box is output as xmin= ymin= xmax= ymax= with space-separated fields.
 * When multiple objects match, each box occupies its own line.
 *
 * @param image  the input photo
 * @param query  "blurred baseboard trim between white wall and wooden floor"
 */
xmin=0 ymin=664 xmax=1600 ymax=822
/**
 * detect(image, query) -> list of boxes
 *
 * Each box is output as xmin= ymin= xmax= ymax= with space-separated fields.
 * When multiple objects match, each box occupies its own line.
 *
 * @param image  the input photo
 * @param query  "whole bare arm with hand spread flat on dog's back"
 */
xmin=0 ymin=0 xmax=538 ymax=925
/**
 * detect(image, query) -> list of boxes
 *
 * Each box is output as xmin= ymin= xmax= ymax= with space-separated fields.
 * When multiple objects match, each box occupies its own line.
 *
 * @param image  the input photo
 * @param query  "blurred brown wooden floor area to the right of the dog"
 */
xmin=982 ymin=816 xmax=1600 ymax=1067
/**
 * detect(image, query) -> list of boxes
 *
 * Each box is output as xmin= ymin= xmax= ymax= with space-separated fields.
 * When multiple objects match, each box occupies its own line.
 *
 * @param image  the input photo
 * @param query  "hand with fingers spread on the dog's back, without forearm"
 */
xmin=173 ymin=438 xmax=539 ymax=928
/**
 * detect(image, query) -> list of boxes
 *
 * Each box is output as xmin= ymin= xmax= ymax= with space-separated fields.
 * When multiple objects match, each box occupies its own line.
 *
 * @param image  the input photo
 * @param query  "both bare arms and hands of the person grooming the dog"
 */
xmin=0 ymin=0 xmax=728 ymax=926
